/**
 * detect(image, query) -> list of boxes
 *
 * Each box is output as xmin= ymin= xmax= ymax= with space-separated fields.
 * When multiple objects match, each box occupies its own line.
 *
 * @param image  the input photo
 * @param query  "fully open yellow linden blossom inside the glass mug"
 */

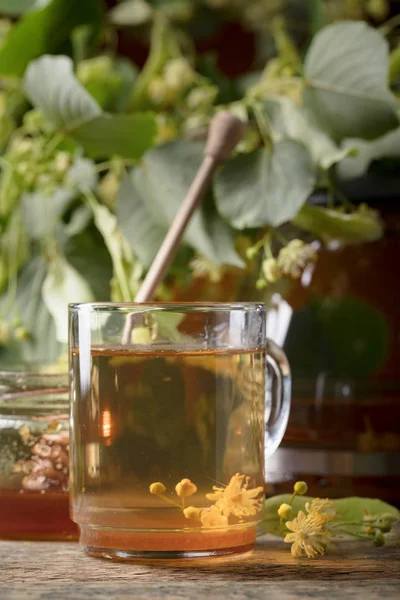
xmin=206 ymin=473 xmax=264 ymax=517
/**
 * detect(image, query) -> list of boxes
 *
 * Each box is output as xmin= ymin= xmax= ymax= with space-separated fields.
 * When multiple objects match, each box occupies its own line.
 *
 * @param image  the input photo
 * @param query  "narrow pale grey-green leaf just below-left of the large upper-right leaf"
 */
xmin=264 ymin=96 xmax=350 ymax=169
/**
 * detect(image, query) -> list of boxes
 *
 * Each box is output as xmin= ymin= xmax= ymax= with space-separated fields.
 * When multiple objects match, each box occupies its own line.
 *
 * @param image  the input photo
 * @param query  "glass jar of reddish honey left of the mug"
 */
xmin=0 ymin=363 xmax=77 ymax=540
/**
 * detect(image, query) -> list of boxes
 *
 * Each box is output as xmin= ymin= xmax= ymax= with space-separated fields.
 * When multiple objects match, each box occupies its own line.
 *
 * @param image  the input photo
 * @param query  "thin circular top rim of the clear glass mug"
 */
xmin=68 ymin=302 xmax=266 ymax=312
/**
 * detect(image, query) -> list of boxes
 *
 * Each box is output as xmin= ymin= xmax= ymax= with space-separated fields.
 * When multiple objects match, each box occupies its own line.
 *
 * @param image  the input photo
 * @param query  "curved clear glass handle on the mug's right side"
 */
xmin=265 ymin=339 xmax=292 ymax=458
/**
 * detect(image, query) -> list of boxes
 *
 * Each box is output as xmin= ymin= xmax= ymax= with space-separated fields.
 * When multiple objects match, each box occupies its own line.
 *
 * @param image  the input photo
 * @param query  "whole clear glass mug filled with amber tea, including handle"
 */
xmin=69 ymin=303 xmax=290 ymax=560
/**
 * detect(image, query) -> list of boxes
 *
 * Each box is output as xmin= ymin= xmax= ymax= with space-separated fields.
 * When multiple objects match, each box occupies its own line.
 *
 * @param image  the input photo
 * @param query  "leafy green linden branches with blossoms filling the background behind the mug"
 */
xmin=0 ymin=0 xmax=400 ymax=362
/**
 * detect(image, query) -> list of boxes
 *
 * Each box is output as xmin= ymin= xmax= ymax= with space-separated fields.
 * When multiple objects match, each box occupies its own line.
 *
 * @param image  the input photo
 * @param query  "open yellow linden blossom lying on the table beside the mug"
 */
xmin=284 ymin=510 xmax=331 ymax=558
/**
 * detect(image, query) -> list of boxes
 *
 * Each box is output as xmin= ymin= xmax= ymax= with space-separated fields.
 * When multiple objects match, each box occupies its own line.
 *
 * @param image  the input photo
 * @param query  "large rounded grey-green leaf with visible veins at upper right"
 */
xmin=304 ymin=21 xmax=399 ymax=141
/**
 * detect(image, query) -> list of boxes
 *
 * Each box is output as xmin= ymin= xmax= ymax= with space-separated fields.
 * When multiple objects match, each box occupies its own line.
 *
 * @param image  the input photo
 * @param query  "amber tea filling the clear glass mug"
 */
xmin=72 ymin=348 xmax=265 ymax=551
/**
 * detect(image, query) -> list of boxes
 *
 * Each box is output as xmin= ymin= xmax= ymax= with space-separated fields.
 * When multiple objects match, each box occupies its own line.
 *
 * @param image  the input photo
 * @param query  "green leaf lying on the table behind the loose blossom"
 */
xmin=261 ymin=494 xmax=400 ymax=537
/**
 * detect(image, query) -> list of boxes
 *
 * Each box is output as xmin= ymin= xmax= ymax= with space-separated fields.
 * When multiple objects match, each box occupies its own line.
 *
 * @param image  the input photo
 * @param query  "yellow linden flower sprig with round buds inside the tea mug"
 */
xmin=149 ymin=473 xmax=264 ymax=529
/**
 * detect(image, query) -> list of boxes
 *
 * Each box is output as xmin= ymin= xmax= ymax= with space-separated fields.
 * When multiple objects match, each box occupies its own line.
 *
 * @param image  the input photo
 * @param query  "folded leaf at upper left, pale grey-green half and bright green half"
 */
xmin=24 ymin=56 xmax=156 ymax=159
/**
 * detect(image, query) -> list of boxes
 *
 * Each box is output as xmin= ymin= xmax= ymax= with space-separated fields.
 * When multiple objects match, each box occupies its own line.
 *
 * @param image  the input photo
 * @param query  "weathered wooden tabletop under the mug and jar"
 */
xmin=0 ymin=536 xmax=400 ymax=600
